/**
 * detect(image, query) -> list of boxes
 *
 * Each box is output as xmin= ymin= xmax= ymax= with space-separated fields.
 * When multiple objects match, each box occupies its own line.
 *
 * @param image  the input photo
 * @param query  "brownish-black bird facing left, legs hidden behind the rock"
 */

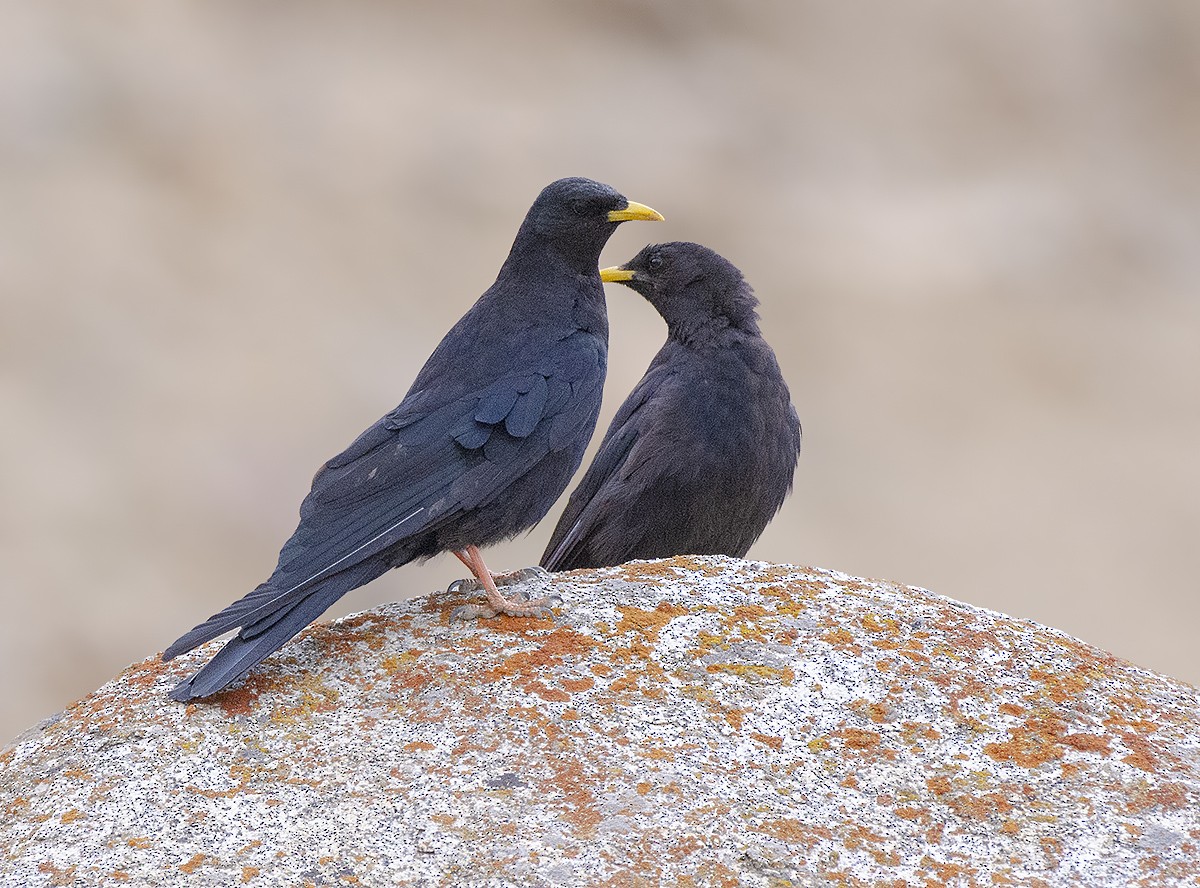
xmin=541 ymin=242 xmax=800 ymax=570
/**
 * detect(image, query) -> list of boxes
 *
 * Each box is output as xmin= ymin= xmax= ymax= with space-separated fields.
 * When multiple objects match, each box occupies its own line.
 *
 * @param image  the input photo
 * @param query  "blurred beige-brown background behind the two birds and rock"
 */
xmin=0 ymin=0 xmax=1200 ymax=742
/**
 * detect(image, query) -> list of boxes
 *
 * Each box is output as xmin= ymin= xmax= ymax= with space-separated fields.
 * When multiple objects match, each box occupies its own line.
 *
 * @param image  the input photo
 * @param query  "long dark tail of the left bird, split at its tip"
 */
xmin=162 ymin=562 xmax=388 ymax=703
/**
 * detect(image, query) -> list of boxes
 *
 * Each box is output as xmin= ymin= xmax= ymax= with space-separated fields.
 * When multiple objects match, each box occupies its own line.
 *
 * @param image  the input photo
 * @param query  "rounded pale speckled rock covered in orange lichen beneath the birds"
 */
xmin=7 ymin=558 xmax=1200 ymax=886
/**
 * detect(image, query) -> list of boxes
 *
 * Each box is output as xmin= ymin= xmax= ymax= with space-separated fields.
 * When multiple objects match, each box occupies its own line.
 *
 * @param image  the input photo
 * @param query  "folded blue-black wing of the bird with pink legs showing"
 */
xmin=163 ymin=348 xmax=600 ymax=659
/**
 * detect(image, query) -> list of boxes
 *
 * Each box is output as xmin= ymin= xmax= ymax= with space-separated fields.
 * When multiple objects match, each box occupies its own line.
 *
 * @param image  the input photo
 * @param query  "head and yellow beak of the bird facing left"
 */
xmin=600 ymin=241 xmax=758 ymax=334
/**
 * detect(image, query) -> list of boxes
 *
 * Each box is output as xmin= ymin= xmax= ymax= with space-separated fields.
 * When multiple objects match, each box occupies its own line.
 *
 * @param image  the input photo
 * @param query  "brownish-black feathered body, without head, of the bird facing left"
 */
xmin=542 ymin=329 xmax=800 ymax=570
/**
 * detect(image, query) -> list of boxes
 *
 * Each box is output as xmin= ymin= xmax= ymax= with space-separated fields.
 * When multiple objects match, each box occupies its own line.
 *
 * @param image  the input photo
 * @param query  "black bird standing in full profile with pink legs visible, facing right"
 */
xmin=162 ymin=179 xmax=662 ymax=701
